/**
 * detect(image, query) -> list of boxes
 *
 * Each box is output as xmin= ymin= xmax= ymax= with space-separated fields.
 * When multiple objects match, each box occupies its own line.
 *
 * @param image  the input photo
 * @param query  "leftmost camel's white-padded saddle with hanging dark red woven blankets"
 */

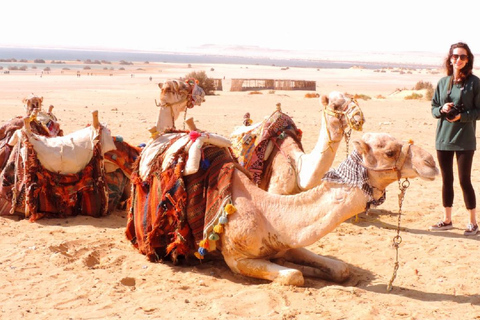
xmin=0 ymin=108 xmax=140 ymax=221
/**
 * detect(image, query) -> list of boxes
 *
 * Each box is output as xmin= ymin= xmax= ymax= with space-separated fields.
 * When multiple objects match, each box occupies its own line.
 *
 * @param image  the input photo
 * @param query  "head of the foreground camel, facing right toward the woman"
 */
xmin=354 ymin=133 xmax=439 ymax=184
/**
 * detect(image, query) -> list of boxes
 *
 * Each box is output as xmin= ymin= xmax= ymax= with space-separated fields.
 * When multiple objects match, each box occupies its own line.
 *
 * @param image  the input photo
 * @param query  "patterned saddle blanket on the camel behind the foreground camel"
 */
xmin=231 ymin=111 xmax=302 ymax=185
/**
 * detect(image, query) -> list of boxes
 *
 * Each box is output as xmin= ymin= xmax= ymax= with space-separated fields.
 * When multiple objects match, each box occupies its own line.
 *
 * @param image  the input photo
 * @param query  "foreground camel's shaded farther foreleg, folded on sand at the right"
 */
xmin=283 ymin=248 xmax=350 ymax=283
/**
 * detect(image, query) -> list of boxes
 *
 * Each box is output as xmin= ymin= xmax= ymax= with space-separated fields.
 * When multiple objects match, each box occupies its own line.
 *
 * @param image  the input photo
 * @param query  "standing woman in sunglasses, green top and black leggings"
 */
xmin=430 ymin=42 xmax=480 ymax=236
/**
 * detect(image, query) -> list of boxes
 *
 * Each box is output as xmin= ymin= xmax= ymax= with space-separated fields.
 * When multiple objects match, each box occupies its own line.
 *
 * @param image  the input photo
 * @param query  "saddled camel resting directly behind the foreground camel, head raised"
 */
xmin=231 ymin=91 xmax=365 ymax=194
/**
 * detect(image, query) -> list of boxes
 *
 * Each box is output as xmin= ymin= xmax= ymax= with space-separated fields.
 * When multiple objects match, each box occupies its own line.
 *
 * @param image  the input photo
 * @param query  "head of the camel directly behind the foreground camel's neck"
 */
xmin=320 ymin=91 xmax=365 ymax=131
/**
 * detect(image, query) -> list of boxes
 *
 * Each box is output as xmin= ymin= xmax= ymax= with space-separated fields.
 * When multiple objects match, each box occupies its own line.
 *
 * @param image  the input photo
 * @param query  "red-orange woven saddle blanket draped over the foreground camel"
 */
xmin=126 ymin=136 xmax=237 ymax=262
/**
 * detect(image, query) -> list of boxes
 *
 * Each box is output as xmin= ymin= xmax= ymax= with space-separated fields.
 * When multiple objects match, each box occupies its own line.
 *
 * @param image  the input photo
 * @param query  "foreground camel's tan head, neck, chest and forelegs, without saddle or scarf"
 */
xmin=219 ymin=134 xmax=438 ymax=285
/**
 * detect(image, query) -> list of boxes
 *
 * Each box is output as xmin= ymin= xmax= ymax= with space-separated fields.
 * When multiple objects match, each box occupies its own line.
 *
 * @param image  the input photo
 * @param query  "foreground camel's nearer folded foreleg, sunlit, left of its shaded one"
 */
xmin=225 ymin=258 xmax=304 ymax=286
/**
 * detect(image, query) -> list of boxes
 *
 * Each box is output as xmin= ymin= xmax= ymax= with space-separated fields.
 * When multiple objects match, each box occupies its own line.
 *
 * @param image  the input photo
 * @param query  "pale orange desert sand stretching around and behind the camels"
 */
xmin=0 ymin=58 xmax=480 ymax=320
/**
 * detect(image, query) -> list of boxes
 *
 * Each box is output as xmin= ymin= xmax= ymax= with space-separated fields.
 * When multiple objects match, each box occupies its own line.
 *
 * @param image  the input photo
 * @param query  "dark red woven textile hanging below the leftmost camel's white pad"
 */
xmin=0 ymin=127 xmax=108 ymax=221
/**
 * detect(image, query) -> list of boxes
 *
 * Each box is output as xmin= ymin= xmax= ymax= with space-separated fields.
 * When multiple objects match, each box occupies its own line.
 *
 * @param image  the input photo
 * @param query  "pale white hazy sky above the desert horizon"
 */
xmin=0 ymin=0 xmax=480 ymax=53
